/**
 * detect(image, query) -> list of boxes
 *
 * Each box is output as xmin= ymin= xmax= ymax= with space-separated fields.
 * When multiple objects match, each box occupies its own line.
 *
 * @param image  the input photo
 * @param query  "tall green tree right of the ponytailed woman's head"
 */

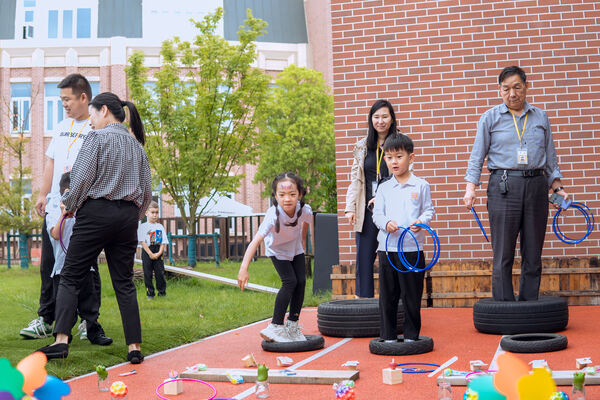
xmin=126 ymin=8 xmax=270 ymax=266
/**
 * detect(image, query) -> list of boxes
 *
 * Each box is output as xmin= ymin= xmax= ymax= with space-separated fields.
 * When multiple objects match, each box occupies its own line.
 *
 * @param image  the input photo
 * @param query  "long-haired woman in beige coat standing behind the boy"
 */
xmin=344 ymin=100 xmax=397 ymax=297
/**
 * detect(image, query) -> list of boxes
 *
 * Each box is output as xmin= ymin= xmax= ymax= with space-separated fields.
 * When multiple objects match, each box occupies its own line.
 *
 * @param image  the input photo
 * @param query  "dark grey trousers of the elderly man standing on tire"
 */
xmin=487 ymin=174 xmax=548 ymax=301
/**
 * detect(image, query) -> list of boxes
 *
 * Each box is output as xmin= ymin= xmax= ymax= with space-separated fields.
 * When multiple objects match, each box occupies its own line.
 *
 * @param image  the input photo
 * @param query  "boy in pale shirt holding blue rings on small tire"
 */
xmin=373 ymin=134 xmax=435 ymax=342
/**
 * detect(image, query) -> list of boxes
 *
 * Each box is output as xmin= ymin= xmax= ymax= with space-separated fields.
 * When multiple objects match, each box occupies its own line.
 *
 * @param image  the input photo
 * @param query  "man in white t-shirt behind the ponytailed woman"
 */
xmin=20 ymin=74 xmax=106 ymax=343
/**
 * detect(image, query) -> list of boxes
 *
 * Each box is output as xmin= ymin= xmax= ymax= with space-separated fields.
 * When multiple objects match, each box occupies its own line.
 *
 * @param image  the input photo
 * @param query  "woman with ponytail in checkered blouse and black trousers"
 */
xmin=38 ymin=92 xmax=152 ymax=364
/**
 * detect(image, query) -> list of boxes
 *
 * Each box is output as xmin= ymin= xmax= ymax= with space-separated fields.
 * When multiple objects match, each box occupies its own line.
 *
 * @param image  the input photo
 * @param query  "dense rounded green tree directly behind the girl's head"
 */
xmin=255 ymin=65 xmax=337 ymax=212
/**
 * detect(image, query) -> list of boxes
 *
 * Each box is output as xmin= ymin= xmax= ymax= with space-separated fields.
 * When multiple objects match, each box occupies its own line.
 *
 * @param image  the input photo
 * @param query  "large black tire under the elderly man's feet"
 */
xmin=473 ymin=296 xmax=569 ymax=335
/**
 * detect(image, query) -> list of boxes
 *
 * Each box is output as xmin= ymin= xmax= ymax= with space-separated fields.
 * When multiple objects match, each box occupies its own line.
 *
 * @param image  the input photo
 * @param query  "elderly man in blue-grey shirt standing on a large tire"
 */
xmin=463 ymin=66 xmax=569 ymax=301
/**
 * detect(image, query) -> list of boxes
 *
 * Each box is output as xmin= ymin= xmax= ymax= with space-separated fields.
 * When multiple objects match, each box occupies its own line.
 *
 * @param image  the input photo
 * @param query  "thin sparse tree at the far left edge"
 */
xmin=0 ymin=92 xmax=42 ymax=268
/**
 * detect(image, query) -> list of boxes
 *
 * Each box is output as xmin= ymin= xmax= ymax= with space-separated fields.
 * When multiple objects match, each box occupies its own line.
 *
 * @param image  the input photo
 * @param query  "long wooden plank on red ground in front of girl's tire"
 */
xmin=181 ymin=368 xmax=359 ymax=385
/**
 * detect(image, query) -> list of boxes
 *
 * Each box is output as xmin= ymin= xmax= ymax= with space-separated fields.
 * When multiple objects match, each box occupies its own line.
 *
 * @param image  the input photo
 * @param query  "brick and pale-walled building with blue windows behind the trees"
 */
xmin=0 ymin=0 xmax=332 ymax=216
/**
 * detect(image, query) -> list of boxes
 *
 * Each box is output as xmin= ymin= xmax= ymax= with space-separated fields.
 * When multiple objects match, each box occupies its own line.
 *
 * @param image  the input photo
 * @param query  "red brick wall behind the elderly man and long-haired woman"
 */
xmin=331 ymin=0 xmax=600 ymax=262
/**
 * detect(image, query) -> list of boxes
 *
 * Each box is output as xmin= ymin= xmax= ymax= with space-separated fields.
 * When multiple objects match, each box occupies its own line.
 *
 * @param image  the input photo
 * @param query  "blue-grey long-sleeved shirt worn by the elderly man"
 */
xmin=465 ymin=102 xmax=562 ymax=187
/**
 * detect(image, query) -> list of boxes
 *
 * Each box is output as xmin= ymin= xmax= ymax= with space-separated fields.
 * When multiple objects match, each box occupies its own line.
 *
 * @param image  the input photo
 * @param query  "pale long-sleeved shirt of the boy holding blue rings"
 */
xmin=373 ymin=174 xmax=435 ymax=252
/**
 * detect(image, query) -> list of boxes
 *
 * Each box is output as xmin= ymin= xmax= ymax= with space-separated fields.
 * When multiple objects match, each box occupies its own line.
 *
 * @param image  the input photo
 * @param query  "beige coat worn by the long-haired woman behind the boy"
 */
xmin=344 ymin=138 xmax=367 ymax=232
